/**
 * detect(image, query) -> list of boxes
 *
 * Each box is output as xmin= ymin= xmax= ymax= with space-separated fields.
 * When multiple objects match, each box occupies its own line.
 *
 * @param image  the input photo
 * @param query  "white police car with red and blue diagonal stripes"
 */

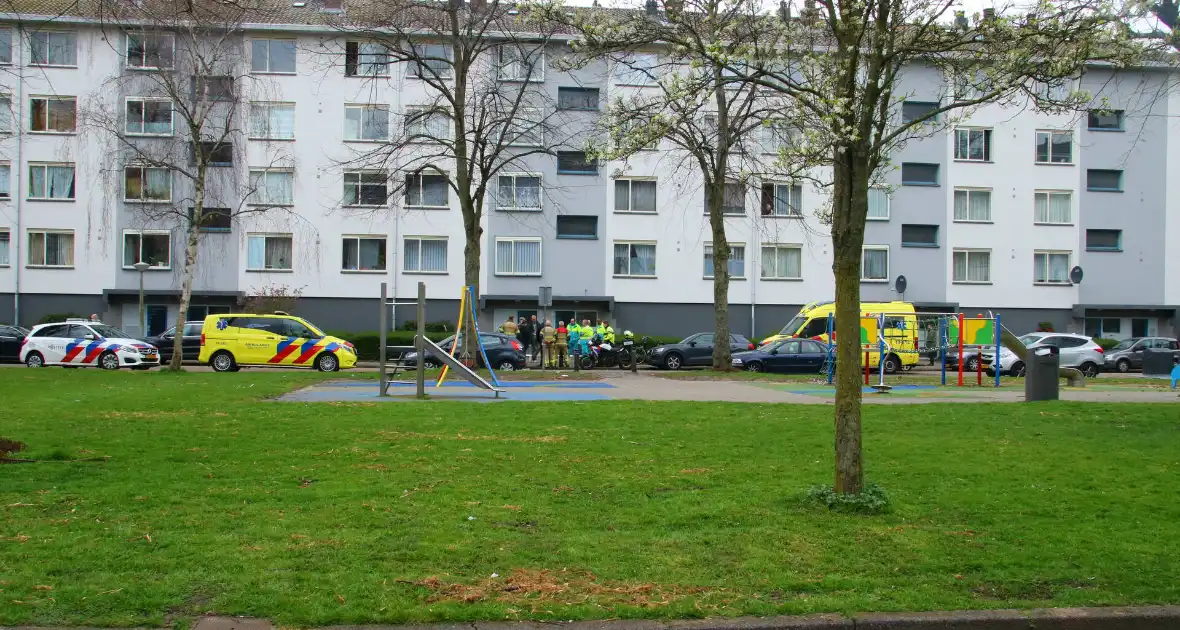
xmin=20 ymin=319 xmax=159 ymax=369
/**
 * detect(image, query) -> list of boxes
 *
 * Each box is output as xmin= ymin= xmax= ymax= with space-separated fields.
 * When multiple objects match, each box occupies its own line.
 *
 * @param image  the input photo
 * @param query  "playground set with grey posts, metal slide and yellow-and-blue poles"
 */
xmin=378 ymin=282 xmax=504 ymax=400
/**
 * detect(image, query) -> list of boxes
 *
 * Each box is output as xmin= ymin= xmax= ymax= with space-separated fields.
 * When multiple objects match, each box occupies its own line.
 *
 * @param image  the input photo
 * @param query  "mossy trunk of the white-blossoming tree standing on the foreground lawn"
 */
xmin=832 ymin=151 xmax=868 ymax=494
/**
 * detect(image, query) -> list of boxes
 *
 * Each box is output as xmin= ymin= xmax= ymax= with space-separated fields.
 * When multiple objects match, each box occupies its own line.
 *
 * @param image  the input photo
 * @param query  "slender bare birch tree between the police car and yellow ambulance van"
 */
xmin=87 ymin=0 xmax=293 ymax=369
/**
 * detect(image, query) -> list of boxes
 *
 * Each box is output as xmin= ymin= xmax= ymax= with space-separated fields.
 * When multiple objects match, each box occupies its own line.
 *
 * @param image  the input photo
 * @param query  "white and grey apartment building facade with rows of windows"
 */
xmin=0 ymin=2 xmax=1180 ymax=339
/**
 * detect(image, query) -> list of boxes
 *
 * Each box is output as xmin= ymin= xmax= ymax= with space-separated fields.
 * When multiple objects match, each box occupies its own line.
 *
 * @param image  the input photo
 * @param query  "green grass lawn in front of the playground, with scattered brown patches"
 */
xmin=0 ymin=369 xmax=1180 ymax=626
